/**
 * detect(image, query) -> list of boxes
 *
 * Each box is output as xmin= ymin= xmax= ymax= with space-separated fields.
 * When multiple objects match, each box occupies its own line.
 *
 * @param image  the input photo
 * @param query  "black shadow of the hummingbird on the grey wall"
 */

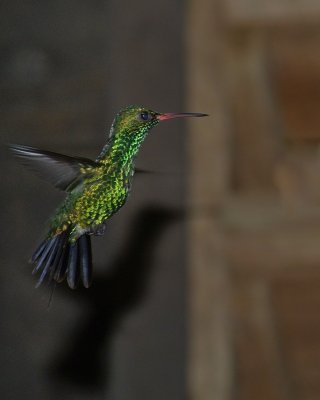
xmin=49 ymin=207 xmax=182 ymax=391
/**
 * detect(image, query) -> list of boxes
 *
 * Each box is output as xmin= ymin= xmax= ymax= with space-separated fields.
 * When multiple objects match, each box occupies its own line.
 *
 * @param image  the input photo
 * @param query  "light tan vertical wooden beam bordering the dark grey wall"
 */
xmin=186 ymin=0 xmax=232 ymax=400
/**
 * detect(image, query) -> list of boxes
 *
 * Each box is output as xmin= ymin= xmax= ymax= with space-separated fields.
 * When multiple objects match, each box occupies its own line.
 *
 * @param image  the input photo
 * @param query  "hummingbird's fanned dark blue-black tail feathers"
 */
xmin=30 ymin=231 xmax=92 ymax=289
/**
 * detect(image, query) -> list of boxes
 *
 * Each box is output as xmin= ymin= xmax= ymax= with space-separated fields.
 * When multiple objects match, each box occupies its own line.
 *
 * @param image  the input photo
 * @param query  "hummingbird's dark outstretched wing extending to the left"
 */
xmin=9 ymin=144 xmax=96 ymax=192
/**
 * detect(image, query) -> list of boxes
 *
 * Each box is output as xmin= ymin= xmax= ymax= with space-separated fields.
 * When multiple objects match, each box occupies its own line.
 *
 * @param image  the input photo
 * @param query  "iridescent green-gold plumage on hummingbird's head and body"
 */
xmin=50 ymin=106 xmax=159 ymax=241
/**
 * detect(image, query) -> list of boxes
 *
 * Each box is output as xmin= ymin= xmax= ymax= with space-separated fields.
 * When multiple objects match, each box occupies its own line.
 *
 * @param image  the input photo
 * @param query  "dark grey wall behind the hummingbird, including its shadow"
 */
xmin=0 ymin=0 xmax=188 ymax=400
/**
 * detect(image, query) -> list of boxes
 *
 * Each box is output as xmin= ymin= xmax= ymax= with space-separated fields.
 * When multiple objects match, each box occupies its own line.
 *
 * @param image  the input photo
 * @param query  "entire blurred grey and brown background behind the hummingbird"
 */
xmin=0 ymin=0 xmax=320 ymax=400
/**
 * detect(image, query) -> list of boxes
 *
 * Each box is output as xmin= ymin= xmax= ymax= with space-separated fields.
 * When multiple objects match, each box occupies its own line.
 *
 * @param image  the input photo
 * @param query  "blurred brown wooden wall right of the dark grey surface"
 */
xmin=187 ymin=0 xmax=320 ymax=400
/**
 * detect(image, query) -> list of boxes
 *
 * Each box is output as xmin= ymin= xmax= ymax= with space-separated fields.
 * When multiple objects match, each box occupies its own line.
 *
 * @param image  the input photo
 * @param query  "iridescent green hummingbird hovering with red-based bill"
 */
xmin=10 ymin=106 xmax=207 ymax=289
